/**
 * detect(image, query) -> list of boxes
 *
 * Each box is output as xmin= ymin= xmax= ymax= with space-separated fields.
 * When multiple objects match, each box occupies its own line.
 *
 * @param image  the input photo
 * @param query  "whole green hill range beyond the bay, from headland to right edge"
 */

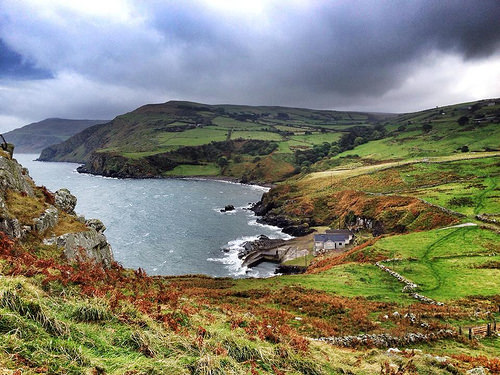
xmin=40 ymin=99 xmax=500 ymax=182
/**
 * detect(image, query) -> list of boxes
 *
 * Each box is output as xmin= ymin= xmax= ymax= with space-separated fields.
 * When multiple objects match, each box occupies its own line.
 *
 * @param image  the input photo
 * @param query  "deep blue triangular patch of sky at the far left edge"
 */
xmin=0 ymin=39 xmax=53 ymax=79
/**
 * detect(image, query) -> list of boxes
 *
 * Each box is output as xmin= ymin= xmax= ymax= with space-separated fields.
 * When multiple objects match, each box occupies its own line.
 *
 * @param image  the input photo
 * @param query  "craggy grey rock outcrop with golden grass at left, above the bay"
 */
xmin=0 ymin=152 xmax=114 ymax=266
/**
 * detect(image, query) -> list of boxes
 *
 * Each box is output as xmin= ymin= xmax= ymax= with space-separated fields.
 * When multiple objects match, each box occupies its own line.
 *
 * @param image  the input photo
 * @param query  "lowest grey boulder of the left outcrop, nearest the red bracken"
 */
xmin=55 ymin=228 xmax=114 ymax=267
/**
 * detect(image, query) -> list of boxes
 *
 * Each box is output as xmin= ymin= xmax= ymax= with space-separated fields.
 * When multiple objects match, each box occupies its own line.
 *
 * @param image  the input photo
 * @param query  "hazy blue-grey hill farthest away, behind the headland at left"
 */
xmin=4 ymin=118 xmax=109 ymax=153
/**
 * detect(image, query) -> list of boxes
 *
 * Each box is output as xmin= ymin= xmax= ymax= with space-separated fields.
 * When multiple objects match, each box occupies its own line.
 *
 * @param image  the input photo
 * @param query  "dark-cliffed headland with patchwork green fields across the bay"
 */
xmin=40 ymin=101 xmax=387 ymax=181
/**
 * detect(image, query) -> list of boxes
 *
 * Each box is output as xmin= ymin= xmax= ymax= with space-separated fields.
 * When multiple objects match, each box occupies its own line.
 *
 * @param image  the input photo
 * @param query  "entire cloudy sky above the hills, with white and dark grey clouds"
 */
xmin=0 ymin=0 xmax=500 ymax=131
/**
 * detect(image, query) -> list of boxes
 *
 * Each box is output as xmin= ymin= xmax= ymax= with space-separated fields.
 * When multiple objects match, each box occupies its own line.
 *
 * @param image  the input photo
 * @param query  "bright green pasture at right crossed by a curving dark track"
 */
xmin=366 ymin=227 xmax=500 ymax=300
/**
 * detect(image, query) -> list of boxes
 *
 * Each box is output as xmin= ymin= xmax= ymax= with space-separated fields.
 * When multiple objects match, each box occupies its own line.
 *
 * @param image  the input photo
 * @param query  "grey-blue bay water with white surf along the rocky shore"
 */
xmin=15 ymin=154 xmax=289 ymax=277
